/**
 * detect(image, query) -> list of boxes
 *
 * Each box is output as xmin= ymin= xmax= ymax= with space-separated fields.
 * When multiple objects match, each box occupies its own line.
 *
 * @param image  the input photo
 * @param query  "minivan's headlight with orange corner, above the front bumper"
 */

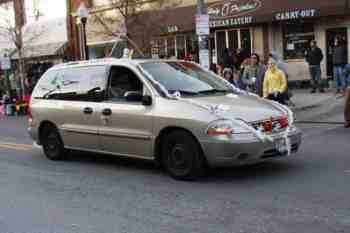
xmin=206 ymin=119 xmax=251 ymax=136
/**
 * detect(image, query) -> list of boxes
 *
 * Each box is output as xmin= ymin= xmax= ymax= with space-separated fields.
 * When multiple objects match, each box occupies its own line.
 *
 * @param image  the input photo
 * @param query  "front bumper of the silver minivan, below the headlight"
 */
xmin=200 ymin=128 xmax=302 ymax=167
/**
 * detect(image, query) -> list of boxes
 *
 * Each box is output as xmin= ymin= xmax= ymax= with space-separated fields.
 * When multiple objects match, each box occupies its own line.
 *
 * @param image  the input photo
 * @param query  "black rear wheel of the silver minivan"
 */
xmin=41 ymin=125 xmax=67 ymax=161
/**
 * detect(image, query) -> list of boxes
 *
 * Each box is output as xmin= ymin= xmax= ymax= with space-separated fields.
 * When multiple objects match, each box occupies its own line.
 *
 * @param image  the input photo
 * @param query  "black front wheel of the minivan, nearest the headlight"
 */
xmin=161 ymin=130 xmax=206 ymax=181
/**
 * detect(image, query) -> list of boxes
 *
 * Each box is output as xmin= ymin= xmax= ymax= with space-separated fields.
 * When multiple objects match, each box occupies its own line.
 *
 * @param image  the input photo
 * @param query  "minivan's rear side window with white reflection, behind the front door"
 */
xmin=34 ymin=66 xmax=106 ymax=101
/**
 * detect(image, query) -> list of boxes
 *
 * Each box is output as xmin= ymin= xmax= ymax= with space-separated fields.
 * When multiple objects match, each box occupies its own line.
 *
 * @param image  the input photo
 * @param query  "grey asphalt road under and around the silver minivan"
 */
xmin=0 ymin=106 xmax=350 ymax=233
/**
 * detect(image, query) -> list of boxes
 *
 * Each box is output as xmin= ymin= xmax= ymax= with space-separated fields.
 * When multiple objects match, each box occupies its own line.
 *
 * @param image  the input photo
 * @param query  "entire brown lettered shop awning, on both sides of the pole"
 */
xmin=128 ymin=0 xmax=349 ymax=35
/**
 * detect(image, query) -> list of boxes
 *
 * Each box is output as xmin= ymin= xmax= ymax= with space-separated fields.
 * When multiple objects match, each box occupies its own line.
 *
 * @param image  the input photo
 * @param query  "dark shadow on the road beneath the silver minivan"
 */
xmin=69 ymin=152 xmax=302 ymax=183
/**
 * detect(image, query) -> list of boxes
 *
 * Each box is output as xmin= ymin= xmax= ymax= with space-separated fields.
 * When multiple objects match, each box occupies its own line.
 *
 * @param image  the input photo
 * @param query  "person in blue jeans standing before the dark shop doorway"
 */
xmin=332 ymin=38 xmax=347 ymax=94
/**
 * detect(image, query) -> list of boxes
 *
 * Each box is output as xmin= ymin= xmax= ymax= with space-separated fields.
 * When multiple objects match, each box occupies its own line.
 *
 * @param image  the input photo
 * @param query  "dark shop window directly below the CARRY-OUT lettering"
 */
xmin=282 ymin=22 xmax=315 ymax=60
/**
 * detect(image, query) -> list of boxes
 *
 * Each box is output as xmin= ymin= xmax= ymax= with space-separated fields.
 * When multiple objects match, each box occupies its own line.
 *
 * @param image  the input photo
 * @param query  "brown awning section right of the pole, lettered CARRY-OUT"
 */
xmin=207 ymin=0 xmax=349 ymax=28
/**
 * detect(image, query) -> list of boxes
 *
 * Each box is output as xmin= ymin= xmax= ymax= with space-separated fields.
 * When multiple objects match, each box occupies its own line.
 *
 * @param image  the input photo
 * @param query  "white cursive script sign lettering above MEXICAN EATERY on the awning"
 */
xmin=208 ymin=0 xmax=261 ymax=20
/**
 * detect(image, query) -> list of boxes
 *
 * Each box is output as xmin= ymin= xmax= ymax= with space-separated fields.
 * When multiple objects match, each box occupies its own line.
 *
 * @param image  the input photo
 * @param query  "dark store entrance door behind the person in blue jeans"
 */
xmin=326 ymin=28 xmax=348 ymax=78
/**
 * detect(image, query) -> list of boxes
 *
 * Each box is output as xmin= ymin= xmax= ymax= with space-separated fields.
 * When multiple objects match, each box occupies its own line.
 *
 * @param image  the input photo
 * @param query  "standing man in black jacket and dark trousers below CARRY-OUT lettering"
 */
xmin=305 ymin=40 xmax=324 ymax=93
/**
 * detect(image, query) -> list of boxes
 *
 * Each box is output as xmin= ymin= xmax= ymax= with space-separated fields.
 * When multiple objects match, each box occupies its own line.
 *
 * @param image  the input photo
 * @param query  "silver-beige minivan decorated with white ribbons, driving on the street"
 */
xmin=29 ymin=58 xmax=301 ymax=180
